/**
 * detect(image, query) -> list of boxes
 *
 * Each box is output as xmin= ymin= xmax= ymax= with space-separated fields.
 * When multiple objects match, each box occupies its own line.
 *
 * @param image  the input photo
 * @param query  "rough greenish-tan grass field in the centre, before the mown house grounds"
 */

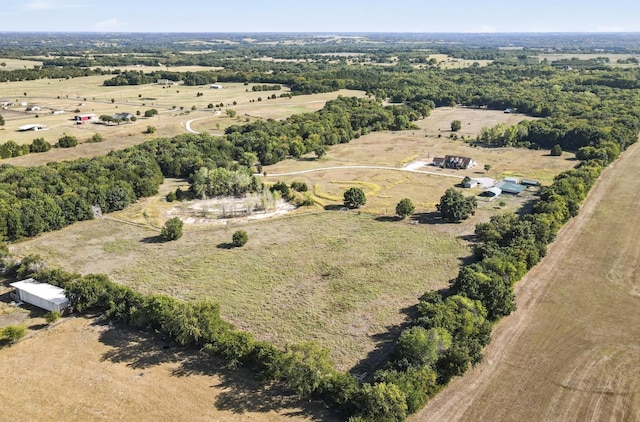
xmin=8 ymin=211 xmax=470 ymax=370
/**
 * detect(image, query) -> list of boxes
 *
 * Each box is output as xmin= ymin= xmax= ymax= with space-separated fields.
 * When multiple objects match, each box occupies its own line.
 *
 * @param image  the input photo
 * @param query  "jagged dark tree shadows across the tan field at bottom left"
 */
xmin=95 ymin=322 xmax=341 ymax=421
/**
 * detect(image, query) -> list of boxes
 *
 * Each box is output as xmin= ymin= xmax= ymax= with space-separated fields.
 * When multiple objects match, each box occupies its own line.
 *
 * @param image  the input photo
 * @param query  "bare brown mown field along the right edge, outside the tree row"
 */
xmin=413 ymin=144 xmax=640 ymax=422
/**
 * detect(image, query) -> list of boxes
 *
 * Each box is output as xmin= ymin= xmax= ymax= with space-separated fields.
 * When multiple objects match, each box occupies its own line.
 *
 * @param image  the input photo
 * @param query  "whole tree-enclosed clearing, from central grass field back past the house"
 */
xmin=3 ymin=108 xmax=574 ymax=370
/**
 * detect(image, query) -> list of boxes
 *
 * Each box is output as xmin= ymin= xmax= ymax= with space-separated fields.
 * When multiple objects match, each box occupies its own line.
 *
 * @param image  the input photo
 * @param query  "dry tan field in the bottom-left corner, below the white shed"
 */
xmin=0 ymin=318 xmax=334 ymax=422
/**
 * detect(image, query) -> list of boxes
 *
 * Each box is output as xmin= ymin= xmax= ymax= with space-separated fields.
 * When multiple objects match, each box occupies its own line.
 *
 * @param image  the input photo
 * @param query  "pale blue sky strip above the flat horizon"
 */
xmin=0 ymin=0 xmax=640 ymax=32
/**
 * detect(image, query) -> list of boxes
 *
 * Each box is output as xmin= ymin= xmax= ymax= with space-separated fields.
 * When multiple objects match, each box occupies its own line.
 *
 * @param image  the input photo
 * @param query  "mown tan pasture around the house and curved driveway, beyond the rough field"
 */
xmin=264 ymin=107 xmax=575 ymax=216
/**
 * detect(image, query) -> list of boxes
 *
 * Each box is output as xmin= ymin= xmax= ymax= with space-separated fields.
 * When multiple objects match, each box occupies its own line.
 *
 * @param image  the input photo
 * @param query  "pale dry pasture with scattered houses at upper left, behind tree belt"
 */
xmin=0 ymin=75 xmax=364 ymax=165
